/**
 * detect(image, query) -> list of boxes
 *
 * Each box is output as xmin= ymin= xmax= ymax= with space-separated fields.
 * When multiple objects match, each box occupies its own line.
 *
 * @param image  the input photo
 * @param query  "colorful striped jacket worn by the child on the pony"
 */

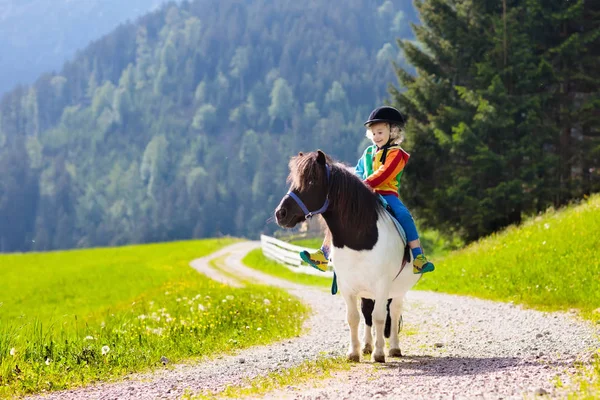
xmin=354 ymin=145 xmax=410 ymax=197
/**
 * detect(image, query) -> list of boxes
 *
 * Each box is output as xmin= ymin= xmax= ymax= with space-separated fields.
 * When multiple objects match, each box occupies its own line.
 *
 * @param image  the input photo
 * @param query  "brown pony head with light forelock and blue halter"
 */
xmin=275 ymin=150 xmax=332 ymax=228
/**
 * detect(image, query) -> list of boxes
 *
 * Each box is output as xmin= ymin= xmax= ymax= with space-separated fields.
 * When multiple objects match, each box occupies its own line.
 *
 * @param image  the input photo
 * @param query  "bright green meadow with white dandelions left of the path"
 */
xmin=0 ymin=239 xmax=307 ymax=397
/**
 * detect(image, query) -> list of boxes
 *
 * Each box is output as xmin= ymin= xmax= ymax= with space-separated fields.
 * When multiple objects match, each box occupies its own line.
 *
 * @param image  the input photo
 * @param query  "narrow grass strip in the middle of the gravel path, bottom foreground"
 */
xmin=184 ymin=357 xmax=350 ymax=400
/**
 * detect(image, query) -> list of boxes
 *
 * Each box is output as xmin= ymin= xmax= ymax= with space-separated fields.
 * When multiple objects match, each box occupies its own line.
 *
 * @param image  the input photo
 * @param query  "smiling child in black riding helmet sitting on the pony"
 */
xmin=300 ymin=106 xmax=435 ymax=274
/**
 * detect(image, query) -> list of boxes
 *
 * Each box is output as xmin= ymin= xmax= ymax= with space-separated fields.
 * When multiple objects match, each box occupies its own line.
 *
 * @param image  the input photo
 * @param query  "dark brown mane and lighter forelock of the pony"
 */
xmin=288 ymin=152 xmax=383 ymax=227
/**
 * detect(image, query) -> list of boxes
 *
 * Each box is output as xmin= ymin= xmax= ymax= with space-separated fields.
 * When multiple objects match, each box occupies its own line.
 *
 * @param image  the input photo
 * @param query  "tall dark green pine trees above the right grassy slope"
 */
xmin=391 ymin=0 xmax=599 ymax=240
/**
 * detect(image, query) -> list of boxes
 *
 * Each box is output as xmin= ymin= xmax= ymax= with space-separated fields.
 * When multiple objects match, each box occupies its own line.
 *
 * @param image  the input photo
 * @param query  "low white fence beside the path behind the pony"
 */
xmin=260 ymin=235 xmax=333 ymax=277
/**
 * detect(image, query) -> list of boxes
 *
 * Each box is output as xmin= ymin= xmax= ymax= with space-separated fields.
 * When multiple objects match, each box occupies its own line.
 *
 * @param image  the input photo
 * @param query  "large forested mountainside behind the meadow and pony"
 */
xmin=0 ymin=0 xmax=416 ymax=251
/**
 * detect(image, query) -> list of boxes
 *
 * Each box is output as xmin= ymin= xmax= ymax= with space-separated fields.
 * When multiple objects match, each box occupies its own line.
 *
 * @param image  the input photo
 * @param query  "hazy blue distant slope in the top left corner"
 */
xmin=0 ymin=0 xmax=180 ymax=94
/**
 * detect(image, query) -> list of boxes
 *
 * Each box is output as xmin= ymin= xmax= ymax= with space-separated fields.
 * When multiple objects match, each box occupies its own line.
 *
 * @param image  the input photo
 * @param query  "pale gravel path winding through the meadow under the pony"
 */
xmin=30 ymin=242 xmax=600 ymax=399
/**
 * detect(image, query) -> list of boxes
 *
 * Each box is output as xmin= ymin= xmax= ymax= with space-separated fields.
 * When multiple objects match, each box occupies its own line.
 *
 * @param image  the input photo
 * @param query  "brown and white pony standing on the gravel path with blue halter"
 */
xmin=275 ymin=150 xmax=420 ymax=362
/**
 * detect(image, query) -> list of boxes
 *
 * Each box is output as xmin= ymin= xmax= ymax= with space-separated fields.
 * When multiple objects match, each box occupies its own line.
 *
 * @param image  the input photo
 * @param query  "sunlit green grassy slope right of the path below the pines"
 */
xmin=418 ymin=196 xmax=600 ymax=318
